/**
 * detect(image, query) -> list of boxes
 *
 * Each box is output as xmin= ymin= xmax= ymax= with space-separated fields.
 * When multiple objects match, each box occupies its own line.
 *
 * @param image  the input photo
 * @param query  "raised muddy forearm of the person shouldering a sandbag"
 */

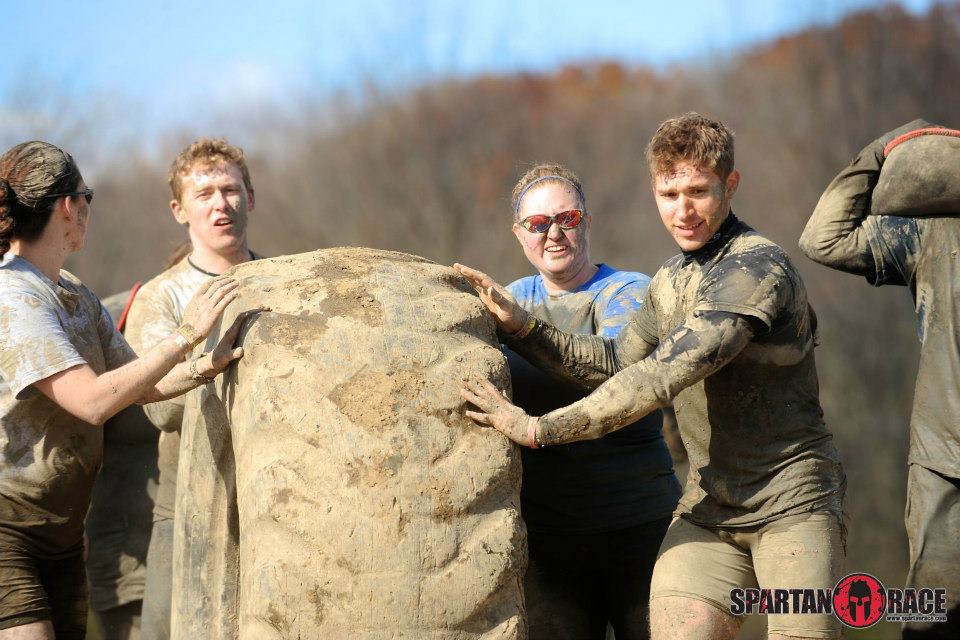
xmin=800 ymin=141 xmax=883 ymax=276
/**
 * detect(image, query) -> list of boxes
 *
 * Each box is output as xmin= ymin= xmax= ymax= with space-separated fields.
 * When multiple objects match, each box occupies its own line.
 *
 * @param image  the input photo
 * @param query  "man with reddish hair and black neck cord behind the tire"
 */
xmin=126 ymin=138 xmax=255 ymax=640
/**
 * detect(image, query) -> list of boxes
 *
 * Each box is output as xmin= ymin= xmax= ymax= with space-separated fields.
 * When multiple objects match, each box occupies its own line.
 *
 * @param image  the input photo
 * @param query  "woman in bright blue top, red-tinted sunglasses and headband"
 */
xmin=498 ymin=164 xmax=680 ymax=640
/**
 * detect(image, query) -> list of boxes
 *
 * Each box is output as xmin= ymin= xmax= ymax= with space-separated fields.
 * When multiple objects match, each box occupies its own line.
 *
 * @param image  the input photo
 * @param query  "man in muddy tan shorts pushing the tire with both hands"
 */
xmin=461 ymin=114 xmax=845 ymax=640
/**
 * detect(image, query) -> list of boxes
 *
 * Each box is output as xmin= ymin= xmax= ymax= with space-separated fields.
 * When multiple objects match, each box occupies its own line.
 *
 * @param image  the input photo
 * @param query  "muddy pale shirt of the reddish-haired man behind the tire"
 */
xmin=125 ymin=258 xmax=212 ymax=519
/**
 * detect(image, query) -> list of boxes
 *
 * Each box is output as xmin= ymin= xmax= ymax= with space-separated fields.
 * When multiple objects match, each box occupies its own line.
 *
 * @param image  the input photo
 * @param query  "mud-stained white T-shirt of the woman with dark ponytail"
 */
xmin=0 ymin=254 xmax=135 ymax=559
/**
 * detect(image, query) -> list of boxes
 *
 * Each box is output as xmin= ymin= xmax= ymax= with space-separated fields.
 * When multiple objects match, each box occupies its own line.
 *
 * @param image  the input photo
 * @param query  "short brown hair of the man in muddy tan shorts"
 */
xmin=647 ymin=111 xmax=733 ymax=180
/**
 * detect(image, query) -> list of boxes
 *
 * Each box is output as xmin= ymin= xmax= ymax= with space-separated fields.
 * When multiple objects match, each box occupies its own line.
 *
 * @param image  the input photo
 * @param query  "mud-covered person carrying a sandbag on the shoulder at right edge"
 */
xmin=800 ymin=120 xmax=960 ymax=638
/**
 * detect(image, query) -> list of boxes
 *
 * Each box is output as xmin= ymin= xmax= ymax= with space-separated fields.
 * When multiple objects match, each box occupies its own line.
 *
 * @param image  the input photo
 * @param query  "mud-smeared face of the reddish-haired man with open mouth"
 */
xmin=170 ymin=164 xmax=253 ymax=253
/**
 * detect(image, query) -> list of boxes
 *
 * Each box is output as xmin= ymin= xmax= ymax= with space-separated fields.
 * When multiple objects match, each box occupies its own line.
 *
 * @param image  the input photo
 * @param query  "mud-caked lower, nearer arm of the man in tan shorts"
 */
xmin=537 ymin=311 xmax=755 ymax=445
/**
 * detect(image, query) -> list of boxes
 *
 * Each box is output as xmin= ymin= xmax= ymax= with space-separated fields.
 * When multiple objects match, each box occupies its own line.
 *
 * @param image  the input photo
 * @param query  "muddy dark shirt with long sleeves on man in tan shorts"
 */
xmin=518 ymin=214 xmax=845 ymax=526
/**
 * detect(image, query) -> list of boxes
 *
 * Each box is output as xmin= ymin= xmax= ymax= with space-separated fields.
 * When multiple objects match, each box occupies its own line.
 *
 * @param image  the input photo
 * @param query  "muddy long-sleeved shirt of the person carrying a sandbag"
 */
xmin=804 ymin=135 xmax=960 ymax=478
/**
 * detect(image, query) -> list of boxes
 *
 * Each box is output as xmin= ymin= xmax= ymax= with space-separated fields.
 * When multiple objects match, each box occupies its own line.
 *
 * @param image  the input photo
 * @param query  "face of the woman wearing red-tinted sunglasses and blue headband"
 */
xmin=513 ymin=182 xmax=591 ymax=283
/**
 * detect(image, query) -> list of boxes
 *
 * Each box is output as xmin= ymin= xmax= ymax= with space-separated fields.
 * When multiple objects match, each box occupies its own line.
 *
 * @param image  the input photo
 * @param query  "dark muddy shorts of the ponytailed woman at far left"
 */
xmin=0 ymin=538 xmax=87 ymax=640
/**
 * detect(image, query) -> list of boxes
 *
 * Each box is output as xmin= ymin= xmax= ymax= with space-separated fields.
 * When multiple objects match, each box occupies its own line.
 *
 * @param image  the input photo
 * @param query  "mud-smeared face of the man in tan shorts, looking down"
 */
xmin=653 ymin=162 xmax=740 ymax=251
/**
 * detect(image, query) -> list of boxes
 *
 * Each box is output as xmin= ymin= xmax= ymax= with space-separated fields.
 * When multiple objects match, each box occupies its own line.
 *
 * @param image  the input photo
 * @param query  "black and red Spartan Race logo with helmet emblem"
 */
xmin=730 ymin=573 xmax=947 ymax=629
